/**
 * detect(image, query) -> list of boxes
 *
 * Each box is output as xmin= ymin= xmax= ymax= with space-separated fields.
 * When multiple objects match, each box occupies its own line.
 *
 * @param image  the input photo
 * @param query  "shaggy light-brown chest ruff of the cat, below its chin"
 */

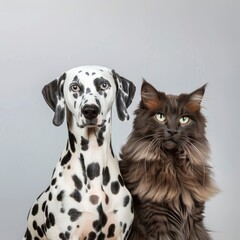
xmin=123 ymin=156 xmax=213 ymax=214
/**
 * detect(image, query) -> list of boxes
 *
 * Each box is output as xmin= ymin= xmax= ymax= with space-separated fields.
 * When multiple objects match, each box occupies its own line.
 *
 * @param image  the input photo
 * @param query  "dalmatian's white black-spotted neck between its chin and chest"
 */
xmin=67 ymin=110 xmax=114 ymax=162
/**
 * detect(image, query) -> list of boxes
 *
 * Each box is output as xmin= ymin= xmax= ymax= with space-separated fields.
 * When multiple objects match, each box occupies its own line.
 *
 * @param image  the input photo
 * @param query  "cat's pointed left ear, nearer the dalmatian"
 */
xmin=141 ymin=79 xmax=161 ymax=111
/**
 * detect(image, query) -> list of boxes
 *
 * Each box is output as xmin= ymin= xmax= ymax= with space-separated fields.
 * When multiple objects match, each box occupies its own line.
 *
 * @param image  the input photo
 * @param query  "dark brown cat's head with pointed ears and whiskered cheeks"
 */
xmin=127 ymin=80 xmax=208 ymax=161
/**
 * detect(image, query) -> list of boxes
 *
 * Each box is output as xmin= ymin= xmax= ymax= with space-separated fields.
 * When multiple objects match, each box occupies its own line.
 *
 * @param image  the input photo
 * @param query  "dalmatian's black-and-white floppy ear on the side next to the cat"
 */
xmin=112 ymin=70 xmax=136 ymax=121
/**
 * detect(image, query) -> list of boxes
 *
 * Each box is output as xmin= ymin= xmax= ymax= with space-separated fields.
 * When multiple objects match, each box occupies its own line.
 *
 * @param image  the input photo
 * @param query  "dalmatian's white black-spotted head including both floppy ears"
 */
xmin=42 ymin=66 xmax=135 ymax=127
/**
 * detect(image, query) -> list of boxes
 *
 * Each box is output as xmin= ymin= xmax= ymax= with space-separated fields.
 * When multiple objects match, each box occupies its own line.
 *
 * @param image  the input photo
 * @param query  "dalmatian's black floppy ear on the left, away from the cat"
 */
xmin=42 ymin=73 xmax=66 ymax=126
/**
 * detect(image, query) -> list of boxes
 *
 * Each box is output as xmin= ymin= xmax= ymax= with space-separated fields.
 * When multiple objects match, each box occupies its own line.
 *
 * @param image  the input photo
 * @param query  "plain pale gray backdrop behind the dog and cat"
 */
xmin=0 ymin=0 xmax=240 ymax=240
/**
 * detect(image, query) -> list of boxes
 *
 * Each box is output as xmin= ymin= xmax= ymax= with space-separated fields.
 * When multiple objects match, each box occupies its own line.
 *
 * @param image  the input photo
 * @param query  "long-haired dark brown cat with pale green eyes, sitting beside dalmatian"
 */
xmin=120 ymin=80 xmax=217 ymax=240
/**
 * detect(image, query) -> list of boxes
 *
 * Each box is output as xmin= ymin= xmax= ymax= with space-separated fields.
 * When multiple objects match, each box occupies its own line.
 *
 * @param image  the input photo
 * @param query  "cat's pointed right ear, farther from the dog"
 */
xmin=187 ymin=84 xmax=207 ymax=112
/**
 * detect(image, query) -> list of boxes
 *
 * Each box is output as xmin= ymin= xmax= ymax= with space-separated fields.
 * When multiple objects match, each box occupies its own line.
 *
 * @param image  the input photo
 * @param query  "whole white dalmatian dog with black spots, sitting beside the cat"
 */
xmin=23 ymin=66 xmax=135 ymax=240
